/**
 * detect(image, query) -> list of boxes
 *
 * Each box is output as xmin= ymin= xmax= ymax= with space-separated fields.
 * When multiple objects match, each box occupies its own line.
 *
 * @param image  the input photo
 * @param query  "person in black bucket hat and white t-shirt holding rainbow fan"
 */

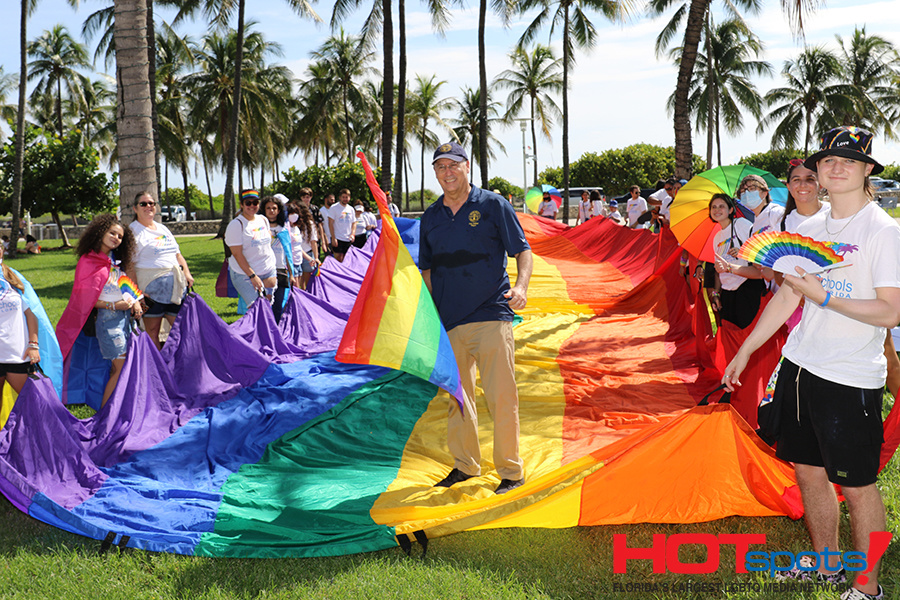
xmin=722 ymin=127 xmax=900 ymax=600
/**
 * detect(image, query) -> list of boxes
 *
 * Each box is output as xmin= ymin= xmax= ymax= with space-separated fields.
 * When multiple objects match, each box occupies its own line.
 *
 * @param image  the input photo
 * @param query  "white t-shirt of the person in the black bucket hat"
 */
xmin=782 ymin=202 xmax=900 ymax=389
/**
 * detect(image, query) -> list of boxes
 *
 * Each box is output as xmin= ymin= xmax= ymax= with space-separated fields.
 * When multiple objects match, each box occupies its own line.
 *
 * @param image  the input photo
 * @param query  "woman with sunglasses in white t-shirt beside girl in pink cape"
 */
xmin=128 ymin=192 xmax=194 ymax=348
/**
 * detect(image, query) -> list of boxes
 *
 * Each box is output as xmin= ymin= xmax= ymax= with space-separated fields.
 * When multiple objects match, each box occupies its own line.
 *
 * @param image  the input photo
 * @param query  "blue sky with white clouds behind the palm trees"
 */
xmin=0 ymin=0 xmax=900 ymax=193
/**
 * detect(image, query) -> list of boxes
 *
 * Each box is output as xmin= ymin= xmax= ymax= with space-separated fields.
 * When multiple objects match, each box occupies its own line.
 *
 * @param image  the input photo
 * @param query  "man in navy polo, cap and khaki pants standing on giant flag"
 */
xmin=419 ymin=142 xmax=532 ymax=494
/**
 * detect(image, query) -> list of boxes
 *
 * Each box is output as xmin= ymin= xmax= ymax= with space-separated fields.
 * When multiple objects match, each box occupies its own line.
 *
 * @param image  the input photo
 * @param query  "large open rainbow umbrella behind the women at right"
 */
xmin=669 ymin=165 xmax=787 ymax=262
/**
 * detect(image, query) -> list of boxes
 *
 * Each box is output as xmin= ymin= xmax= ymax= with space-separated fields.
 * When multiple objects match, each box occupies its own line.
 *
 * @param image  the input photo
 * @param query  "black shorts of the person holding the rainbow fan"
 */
xmin=775 ymin=359 xmax=884 ymax=487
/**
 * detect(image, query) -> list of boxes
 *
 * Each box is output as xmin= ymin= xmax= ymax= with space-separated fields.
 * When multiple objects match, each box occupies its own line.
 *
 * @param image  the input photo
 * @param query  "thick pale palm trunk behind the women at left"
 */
xmin=113 ymin=0 xmax=159 ymax=222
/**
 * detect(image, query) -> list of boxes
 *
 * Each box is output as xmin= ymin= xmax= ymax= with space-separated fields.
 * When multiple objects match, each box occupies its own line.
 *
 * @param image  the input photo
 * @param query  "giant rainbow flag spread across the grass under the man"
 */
xmin=0 ymin=216 xmax=824 ymax=557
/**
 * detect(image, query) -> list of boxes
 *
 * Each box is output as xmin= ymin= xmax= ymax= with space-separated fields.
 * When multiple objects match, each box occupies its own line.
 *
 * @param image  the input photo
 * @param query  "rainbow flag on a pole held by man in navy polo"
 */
xmin=335 ymin=150 xmax=463 ymax=410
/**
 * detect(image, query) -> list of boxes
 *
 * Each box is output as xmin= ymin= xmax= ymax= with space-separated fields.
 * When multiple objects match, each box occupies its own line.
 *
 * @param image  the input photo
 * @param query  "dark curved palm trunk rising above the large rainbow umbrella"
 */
xmin=674 ymin=0 xmax=709 ymax=179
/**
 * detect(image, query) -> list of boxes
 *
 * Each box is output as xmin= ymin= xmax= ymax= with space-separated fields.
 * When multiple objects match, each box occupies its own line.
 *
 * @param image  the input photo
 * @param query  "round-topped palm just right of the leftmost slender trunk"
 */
xmin=28 ymin=25 xmax=91 ymax=137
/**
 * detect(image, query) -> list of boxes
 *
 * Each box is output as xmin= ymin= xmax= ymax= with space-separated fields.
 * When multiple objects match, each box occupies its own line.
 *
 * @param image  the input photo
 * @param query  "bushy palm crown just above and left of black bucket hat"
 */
xmin=757 ymin=46 xmax=853 ymax=154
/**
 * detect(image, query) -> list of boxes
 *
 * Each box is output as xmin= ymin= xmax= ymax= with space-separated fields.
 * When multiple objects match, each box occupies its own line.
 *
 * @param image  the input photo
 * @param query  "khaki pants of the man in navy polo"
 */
xmin=447 ymin=321 xmax=525 ymax=479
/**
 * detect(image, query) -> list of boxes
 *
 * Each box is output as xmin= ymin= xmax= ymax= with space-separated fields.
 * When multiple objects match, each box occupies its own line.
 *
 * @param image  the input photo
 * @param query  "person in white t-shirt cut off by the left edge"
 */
xmin=0 ymin=246 xmax=41 ymax=394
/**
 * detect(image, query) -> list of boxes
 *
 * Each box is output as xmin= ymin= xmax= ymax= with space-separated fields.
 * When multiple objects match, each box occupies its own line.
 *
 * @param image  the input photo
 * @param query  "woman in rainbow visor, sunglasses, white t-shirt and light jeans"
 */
xmin=225 ymin=190 xmax=278 ymax=306
